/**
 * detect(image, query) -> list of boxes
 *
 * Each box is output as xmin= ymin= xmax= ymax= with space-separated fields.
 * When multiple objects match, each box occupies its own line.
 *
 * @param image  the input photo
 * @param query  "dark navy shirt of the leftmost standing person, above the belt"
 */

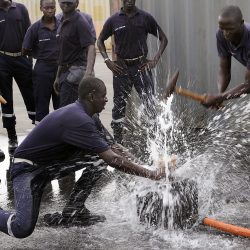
xmin=0 ymin=2 xmax=30 ymax=53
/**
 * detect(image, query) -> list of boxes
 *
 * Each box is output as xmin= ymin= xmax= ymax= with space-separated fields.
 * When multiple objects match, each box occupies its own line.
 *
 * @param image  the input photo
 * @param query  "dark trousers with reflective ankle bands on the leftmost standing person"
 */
xmin=0 ymin=55 xmax=35 ymax=128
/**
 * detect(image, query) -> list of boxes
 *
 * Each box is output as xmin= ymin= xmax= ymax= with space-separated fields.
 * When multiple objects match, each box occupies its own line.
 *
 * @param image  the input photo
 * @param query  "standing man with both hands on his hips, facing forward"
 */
xmin=97 ymin=0 xmax=168 ymax=143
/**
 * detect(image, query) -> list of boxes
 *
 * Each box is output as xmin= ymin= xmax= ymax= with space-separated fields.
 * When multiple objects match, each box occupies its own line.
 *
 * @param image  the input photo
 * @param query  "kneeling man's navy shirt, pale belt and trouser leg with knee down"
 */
xmin=0 ymin=101 xmax=110 ymax=238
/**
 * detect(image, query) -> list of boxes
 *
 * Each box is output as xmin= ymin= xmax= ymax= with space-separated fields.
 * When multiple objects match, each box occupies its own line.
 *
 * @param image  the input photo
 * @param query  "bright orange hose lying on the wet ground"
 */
xmin=203 ymin=217 xmax=250 ymax=238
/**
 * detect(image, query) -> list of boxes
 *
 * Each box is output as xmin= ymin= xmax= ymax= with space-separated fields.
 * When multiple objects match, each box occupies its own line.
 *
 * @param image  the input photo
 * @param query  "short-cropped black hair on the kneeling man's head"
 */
xmin=78 ymin=77 xmax=106 ymax=101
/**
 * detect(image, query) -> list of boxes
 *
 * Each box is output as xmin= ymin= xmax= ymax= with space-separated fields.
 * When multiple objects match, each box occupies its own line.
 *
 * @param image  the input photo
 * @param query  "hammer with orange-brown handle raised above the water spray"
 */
xmin=165 ymin=70 xmax=206 ymax=103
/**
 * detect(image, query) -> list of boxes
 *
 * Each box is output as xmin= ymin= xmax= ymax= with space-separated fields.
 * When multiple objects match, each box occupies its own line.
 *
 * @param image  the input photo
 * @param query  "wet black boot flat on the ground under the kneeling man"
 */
xmin=44 ymin=208 xmax=106 ymax=227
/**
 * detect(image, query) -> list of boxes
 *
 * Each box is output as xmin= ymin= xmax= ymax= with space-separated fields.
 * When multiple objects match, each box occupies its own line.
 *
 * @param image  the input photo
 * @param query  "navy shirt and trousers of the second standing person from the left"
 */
xmin=23 ymin=18 xmax=59 ymax=124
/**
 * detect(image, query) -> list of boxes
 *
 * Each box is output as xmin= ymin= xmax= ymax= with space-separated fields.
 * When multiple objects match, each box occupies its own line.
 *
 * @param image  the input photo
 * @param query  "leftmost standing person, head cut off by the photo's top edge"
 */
xmin=0 ymin=0 xmax=35 ymax=154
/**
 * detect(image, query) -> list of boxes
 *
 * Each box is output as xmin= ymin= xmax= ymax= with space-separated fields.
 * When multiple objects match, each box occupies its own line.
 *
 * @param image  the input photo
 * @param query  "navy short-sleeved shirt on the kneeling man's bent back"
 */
xmin=15 ymin=101 xmax=109 ymax=165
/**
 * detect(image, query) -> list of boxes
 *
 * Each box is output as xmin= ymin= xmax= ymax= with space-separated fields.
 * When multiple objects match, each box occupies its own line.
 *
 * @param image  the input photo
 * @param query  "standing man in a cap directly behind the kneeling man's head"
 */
xmin=54 ymin=0 xmax=96 ymax=107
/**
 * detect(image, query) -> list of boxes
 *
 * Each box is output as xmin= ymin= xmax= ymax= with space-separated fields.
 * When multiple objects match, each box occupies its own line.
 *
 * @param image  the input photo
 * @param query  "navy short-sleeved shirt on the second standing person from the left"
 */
xmin=23 ymin=18 xmax=59 ymax=61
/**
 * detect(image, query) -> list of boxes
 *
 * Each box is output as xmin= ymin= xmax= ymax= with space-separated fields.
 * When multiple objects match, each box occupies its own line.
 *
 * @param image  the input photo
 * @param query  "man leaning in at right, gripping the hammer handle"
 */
xmin=203 ymin=5 xmax=250 ymax=107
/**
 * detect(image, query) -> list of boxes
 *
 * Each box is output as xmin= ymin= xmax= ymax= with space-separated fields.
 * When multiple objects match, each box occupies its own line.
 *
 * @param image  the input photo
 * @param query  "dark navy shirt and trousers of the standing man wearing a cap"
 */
xmin=57 ymin=11 xmax=95 ymax=107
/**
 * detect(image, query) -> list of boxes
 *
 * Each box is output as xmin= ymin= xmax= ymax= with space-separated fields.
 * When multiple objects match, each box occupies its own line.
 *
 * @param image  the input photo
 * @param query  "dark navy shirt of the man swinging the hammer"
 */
xmin=216 ymin=23 xmax=250 ymax=69
